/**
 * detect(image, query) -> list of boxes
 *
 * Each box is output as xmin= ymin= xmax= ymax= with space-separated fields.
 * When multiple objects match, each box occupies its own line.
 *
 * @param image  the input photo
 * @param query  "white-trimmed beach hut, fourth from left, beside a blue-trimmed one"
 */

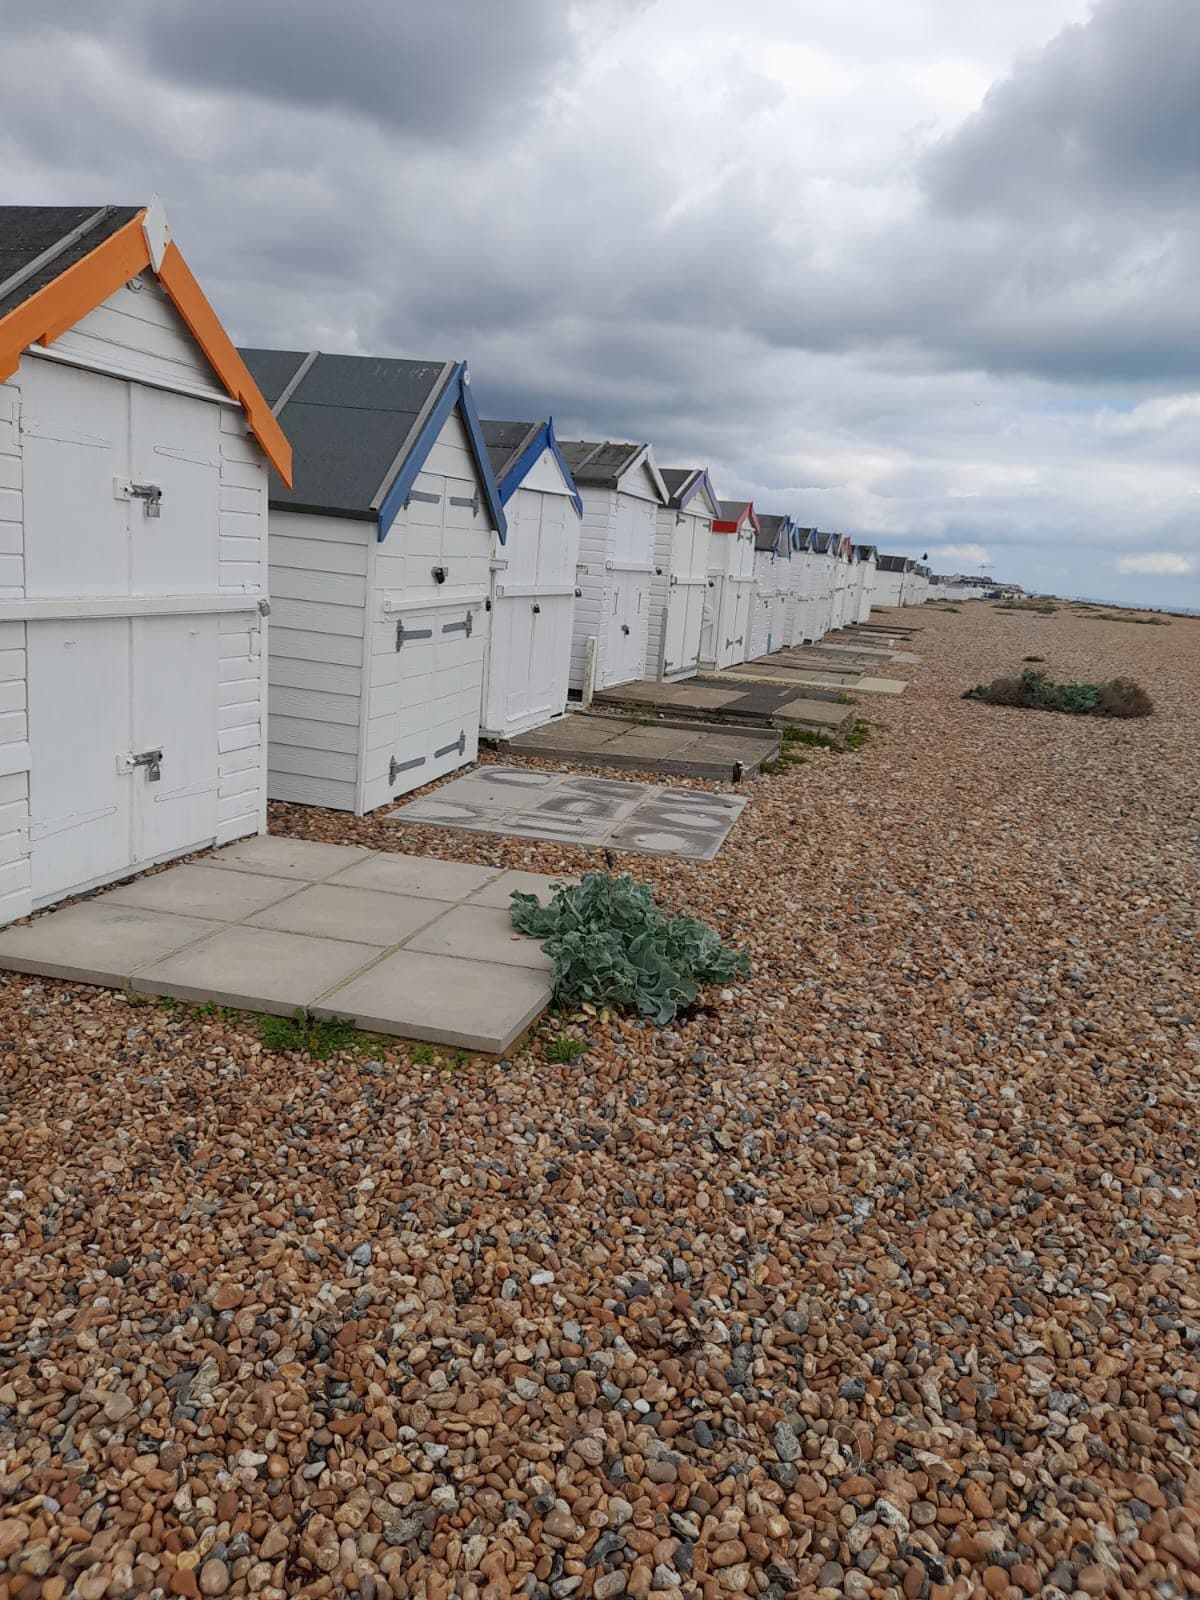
xmin=562 ymin=440 xmax=667 ymax=699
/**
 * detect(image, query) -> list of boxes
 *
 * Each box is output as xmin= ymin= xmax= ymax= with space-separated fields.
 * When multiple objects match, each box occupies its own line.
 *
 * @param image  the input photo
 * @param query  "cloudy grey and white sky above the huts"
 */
xmin=0 ymin=0 xmax=1200 ymax=606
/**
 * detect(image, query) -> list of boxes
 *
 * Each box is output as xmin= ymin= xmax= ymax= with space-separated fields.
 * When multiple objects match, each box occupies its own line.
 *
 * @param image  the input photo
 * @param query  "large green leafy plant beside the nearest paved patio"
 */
xmin=510 ymin=872 xmax=749 ymax=1024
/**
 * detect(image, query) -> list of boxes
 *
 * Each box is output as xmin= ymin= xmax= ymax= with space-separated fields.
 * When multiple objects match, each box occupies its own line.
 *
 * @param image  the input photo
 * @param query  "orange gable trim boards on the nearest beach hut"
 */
xmin=0 ymin=211 xmax=291 ymax=488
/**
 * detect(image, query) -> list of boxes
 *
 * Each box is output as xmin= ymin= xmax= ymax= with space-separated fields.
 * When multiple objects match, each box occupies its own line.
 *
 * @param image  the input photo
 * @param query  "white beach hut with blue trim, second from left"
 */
xmin=243 ymin=349 xmax=507 ymax=816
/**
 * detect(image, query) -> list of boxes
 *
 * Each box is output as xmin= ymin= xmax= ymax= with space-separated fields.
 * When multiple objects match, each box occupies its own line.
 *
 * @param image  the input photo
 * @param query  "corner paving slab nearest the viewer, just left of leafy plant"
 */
xmin=312 ymin=949 xmax=550 ymax=1056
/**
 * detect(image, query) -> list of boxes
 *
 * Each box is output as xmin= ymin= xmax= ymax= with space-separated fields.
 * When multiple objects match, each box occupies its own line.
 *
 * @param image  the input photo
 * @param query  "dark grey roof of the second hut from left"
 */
xmin=242 ymin=350 xmax=454 ymax=518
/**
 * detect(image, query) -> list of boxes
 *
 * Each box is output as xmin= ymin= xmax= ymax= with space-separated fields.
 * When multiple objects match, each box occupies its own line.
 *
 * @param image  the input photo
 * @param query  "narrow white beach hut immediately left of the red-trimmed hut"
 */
xmin=648 ymin=467 xmax=720 ymax=682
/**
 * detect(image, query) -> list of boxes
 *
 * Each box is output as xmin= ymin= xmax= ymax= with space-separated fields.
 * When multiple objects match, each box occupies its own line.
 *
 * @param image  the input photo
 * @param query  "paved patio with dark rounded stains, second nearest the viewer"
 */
xmin=387 ymin=766 xmax=746 ymax=864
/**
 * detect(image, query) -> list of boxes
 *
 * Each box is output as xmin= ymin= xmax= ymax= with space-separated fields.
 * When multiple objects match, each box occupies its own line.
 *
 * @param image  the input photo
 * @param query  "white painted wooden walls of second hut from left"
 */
xmin=269 ymin=411 xmax=493 ymax=814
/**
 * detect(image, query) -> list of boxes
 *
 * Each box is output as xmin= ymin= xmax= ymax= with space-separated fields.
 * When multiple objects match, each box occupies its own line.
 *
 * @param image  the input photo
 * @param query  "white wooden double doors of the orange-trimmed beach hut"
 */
xmin=22 ymin=362 xmax=219 ymax=902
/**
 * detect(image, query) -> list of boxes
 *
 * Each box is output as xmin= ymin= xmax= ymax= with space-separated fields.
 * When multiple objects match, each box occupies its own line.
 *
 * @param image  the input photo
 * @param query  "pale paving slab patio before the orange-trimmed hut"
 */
xmin=0 ymin=844 xmax=563 ymax=1054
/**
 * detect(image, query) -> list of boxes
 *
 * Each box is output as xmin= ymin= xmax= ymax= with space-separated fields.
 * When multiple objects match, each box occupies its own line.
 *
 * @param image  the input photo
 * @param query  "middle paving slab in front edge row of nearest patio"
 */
xmin=130 ymin=925 xmax=384 ymax=1016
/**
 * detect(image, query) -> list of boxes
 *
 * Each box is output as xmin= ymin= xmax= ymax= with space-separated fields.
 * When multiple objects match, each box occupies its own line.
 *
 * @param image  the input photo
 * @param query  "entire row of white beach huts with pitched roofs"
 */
xmin=0 ymin=202 xmax=931 ymax=923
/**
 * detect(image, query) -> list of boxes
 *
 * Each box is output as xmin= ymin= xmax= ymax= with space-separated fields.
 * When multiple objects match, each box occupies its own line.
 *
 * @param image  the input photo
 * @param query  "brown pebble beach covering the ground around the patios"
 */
xmin=0 ymin=603 xmax=1200 ymax=1600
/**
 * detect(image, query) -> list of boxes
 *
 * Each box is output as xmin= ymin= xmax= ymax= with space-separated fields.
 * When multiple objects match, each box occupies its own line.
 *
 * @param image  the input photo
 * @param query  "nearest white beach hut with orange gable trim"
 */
xmin=0 ymin=200 xmax=291 ymax=923
